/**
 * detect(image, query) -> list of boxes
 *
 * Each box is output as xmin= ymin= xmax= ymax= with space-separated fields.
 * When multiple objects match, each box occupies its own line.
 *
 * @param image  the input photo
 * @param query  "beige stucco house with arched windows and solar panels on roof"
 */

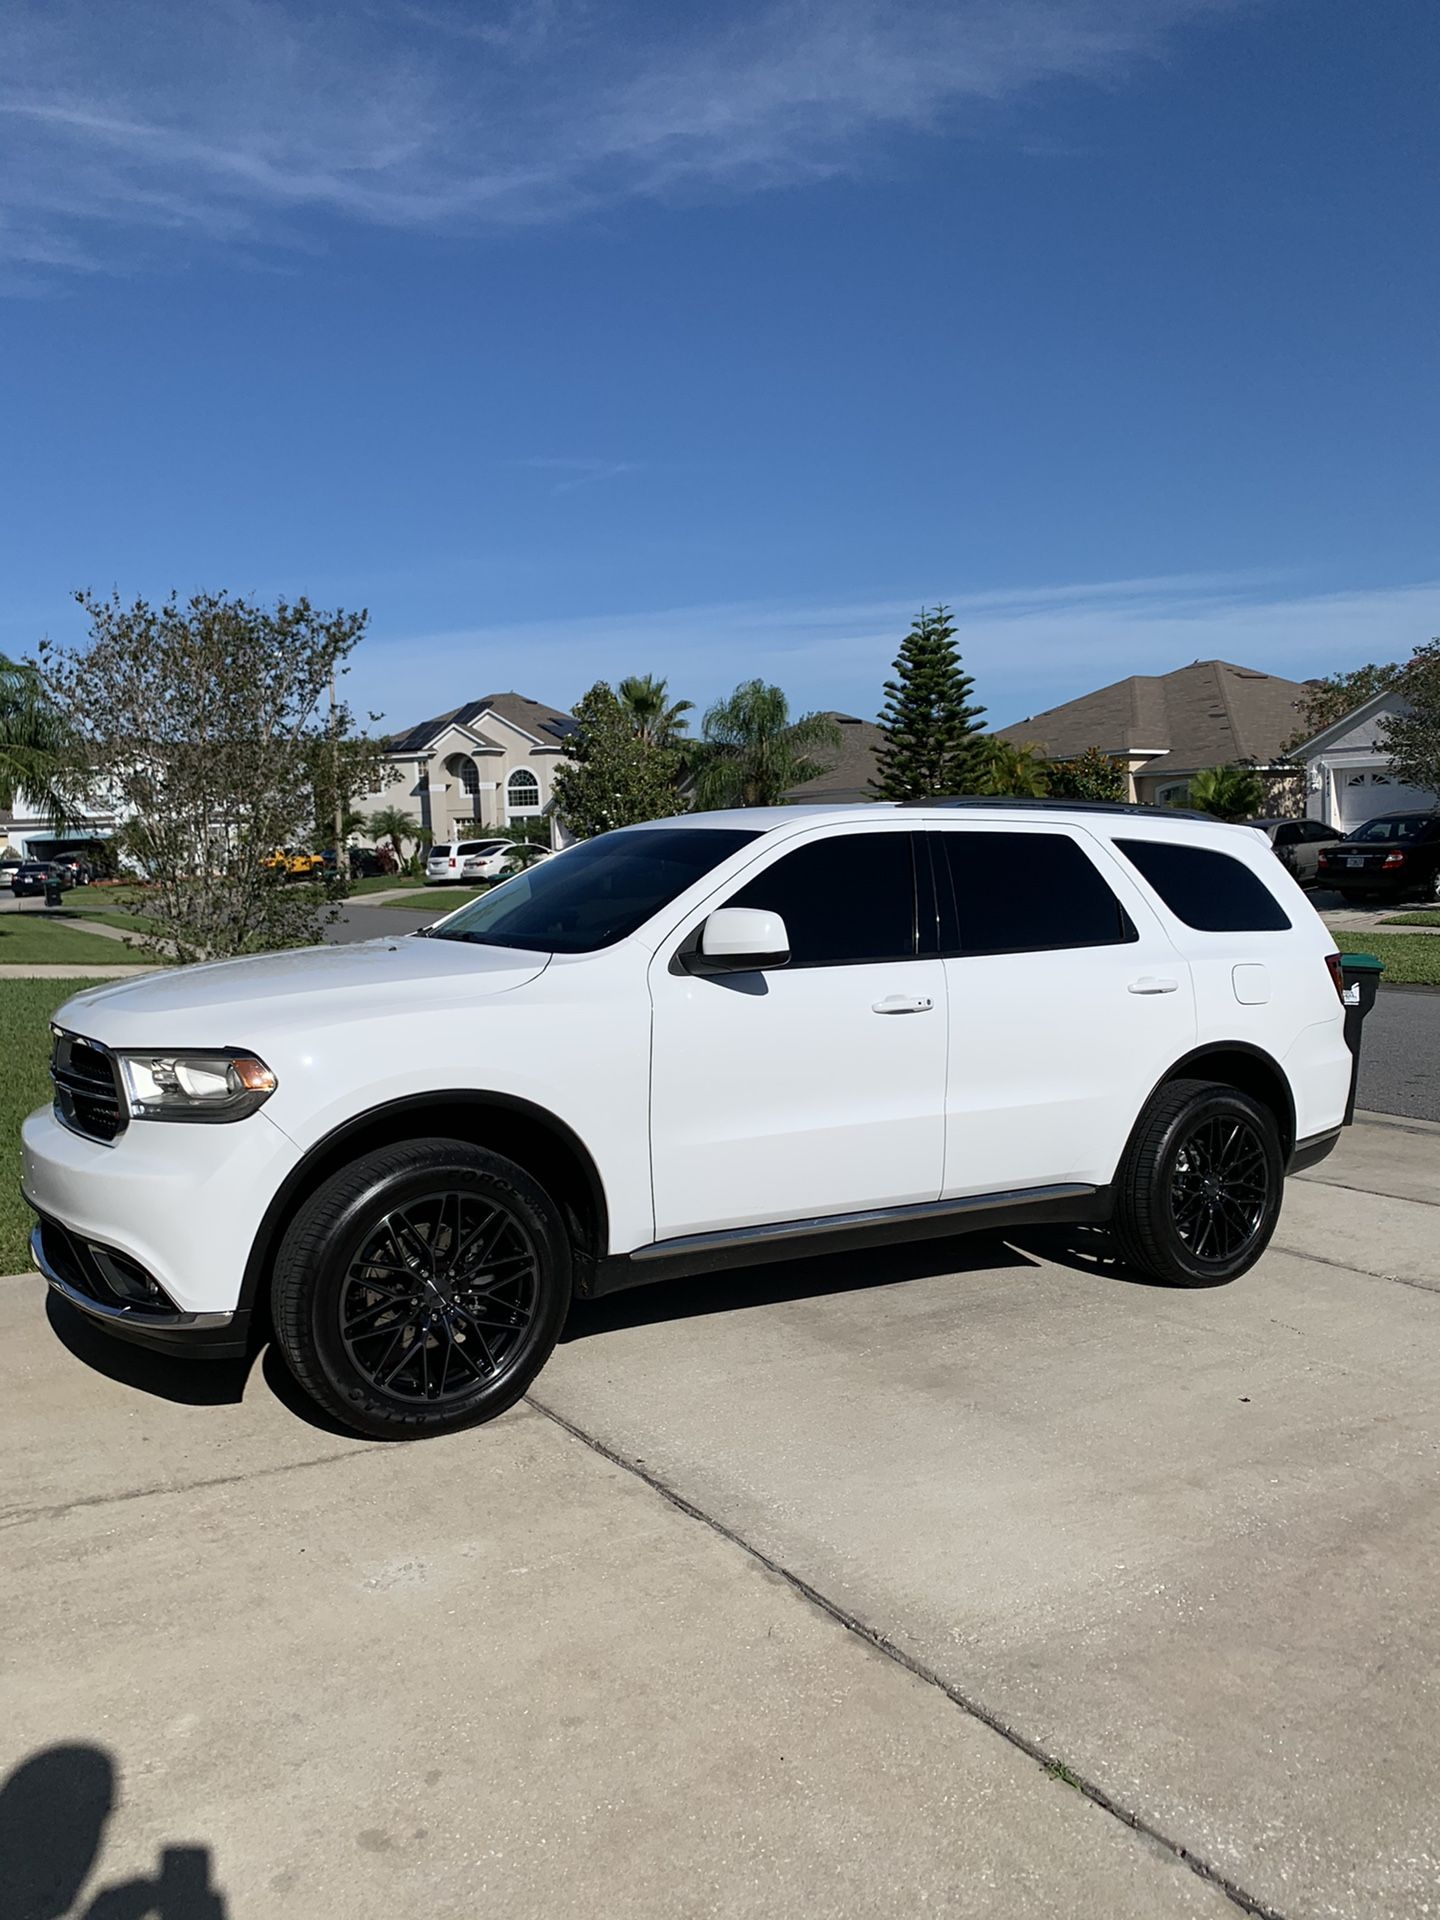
xmin=355 ymin=693 xmax=574 ymax=841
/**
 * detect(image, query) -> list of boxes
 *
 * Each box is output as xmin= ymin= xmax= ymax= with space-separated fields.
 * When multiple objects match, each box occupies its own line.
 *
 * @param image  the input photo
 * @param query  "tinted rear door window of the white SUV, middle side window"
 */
xmin=931 ymin=831 xmax=1137 ymax=954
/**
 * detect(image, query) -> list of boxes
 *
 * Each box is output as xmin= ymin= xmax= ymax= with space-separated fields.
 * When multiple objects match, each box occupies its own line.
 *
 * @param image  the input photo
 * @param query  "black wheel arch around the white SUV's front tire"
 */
xmin=238 ymin=1089 xmax=611 ymax=1323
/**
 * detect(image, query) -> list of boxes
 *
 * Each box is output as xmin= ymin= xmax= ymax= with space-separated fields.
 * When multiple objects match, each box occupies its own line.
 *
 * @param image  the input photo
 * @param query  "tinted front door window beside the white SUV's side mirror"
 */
xmin=726 ymin=833 xmax=916 ymax=966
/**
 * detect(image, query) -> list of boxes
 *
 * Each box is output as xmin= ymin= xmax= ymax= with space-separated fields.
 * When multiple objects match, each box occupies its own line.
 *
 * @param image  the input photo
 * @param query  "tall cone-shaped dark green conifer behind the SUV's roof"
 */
xmin=870 ymin=607 xmax=989 ymax=801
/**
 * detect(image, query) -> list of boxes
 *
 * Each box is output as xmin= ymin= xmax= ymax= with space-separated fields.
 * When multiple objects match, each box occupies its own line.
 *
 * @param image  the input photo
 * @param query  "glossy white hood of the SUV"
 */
xmin=56 ymin=935 xmax=551 ymax=1046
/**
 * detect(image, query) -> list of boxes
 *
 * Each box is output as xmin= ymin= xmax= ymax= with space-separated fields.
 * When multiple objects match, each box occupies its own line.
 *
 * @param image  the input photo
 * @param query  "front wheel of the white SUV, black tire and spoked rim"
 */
xmin=271 ymin=1139 xmax=570 ymax=1440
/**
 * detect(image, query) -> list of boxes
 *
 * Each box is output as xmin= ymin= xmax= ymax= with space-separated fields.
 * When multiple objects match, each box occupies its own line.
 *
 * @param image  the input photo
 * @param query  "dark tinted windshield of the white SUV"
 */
xmin=430 ymin=828 xmax=756 ymax=954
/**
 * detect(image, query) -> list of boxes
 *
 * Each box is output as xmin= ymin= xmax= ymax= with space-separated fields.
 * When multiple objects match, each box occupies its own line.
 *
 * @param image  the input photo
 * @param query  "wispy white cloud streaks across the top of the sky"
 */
xmin=0 ymin=0 xmax=1233 ymax=284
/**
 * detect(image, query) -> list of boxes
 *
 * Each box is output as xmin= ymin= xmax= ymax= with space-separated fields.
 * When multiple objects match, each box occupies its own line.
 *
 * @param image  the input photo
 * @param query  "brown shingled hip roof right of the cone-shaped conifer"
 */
xmin=996 ymin=660 xmax=1304 ymax=774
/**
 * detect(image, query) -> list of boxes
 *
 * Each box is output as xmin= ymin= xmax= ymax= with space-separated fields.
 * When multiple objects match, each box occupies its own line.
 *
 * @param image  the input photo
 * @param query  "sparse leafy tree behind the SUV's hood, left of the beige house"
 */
xmin=40 ymin=593 xmax=378 ymax=960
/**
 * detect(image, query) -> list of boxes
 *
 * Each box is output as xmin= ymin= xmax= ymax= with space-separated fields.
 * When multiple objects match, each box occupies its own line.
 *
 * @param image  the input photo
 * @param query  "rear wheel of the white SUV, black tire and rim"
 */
xmin=1112 ymin=1079 xmax=1284 ymax=1286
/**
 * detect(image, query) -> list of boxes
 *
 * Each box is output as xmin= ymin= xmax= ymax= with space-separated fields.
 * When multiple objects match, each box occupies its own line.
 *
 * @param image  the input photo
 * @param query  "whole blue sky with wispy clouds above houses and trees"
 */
xmin=0 ymin=0 xmax=1440 ymax=724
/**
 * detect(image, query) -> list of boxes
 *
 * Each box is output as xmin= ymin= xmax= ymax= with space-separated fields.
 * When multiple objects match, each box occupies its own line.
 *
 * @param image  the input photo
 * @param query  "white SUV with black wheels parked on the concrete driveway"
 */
xmin=23 ymin=801 xmax=1352 ymax=1434
